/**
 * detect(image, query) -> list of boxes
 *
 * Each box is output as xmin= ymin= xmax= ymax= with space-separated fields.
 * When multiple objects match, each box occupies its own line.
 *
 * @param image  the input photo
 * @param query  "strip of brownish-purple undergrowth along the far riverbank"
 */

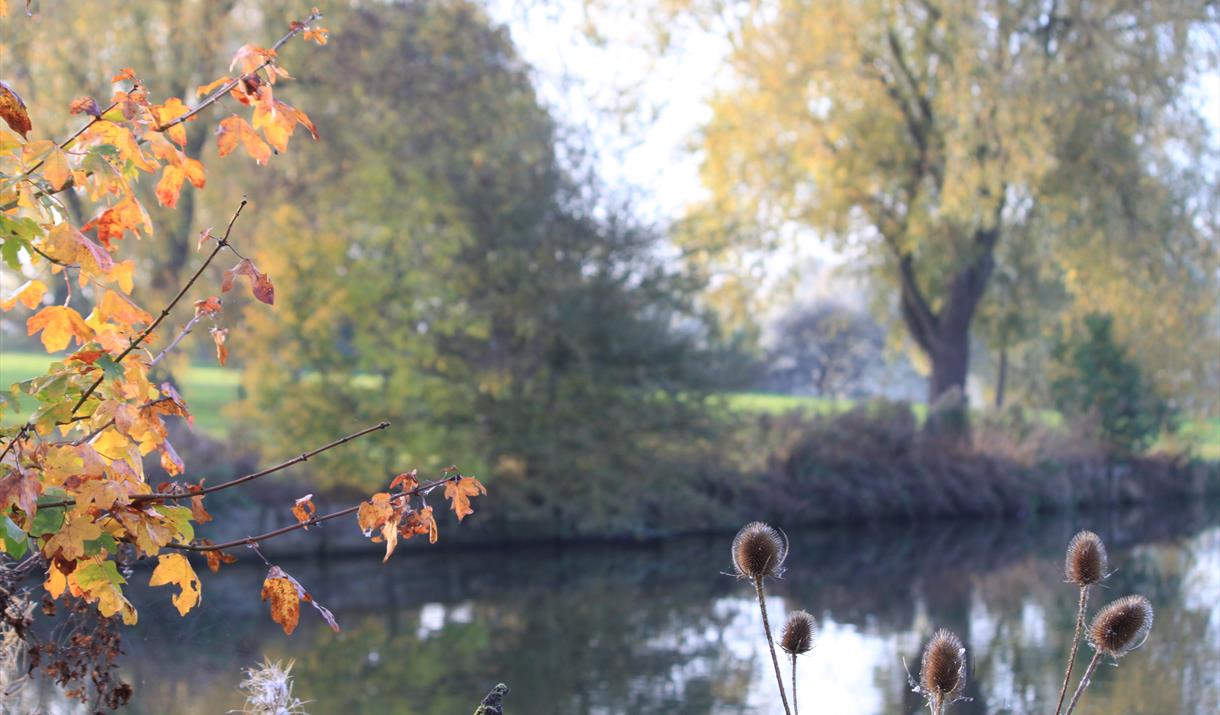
xmin=167 ymin=404 xmax=1220 ymax=556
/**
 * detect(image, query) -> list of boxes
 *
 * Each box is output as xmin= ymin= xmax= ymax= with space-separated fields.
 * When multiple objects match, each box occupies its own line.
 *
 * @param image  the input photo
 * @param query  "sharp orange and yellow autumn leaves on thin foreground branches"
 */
xmin=0 ymin=9 xmax=486 ymax=706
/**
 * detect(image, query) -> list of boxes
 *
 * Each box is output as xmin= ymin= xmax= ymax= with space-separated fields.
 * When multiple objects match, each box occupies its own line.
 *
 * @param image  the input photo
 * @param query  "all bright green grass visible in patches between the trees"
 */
xmin=7 ymin=351 xmax=1220 ymax=460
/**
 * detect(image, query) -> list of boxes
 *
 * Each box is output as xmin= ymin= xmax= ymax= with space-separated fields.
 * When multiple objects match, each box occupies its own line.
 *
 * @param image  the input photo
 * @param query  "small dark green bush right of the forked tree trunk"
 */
xmin=1052 ymin=315 xmax=1174 ymax=453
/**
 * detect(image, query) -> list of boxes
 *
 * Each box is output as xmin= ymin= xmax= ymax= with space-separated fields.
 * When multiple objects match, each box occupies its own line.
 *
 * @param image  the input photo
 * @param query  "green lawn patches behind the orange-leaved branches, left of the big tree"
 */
xmin=0 ymin=350 xmax=242 ymax=437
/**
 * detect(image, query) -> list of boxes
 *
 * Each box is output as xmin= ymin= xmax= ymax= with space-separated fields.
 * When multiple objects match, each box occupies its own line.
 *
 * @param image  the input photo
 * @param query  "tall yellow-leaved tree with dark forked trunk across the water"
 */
xmin=666 ymin=0 xmax=1216 ymax=399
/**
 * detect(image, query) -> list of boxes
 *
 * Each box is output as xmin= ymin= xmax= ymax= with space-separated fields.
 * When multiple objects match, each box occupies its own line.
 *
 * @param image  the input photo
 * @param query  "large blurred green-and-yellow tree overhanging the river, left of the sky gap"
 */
xmin=209 ymin=2 xmax=722 ymax=536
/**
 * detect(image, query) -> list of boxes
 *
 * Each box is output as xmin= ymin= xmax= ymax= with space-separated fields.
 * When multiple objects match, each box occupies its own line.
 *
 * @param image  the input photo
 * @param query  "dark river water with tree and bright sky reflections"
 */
xmin=92 ymin=505 xmax=1220 ymax=715
